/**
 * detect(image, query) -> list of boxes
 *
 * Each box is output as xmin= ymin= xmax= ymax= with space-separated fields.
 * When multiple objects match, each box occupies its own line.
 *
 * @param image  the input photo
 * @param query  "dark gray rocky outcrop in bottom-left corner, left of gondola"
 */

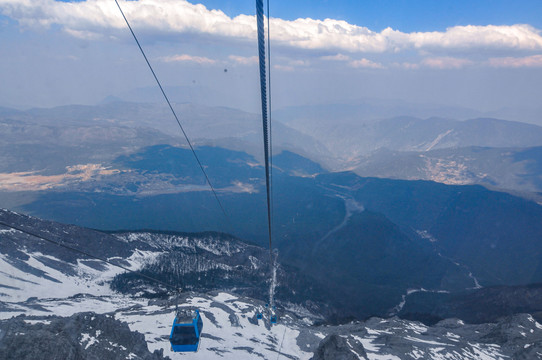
xmin=0 ymin=313 xmax=169 ymax=360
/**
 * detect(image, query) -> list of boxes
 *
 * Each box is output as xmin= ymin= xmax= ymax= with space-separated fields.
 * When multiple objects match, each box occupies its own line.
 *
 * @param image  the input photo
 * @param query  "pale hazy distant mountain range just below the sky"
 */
xmin=5 ymin=101 xmax=542 ymax=200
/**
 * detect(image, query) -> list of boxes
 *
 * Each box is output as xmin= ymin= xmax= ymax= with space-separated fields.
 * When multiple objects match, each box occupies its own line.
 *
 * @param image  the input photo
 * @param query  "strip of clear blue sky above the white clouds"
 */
xmin=200 ymin=0 xmax=542 ymax=32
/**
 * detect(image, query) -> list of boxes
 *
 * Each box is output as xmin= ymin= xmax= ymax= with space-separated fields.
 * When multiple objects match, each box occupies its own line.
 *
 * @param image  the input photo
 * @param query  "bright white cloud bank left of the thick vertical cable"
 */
xmin=0 ymin=0 xmax=256 ymax=38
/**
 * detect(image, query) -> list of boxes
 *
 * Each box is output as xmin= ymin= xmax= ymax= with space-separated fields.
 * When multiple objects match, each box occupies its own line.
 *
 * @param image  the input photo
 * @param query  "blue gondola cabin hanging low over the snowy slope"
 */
xmin=169 ymin=309 xmax=203 ymax=352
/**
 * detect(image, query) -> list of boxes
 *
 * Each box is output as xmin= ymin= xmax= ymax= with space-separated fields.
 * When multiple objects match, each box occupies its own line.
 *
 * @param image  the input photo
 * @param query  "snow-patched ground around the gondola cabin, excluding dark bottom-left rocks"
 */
xmin=0 ymin=292 xmax=542 ymax=360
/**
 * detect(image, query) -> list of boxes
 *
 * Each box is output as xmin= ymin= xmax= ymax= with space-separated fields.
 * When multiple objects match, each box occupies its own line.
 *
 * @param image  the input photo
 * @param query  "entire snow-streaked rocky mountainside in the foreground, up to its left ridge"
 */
xmin=0 ymin=210 xmax=542 ymax=360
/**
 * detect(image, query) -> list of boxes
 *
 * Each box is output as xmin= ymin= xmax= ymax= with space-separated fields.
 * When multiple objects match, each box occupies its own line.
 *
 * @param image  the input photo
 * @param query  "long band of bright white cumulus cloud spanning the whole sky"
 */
xmin=0 ymin=0 xmax=542 ymax=54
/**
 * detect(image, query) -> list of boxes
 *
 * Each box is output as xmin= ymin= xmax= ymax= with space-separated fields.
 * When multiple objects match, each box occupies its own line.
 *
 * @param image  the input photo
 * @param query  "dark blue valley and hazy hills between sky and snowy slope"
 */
xmin=0 ymin=102 xmax=542 ymax=322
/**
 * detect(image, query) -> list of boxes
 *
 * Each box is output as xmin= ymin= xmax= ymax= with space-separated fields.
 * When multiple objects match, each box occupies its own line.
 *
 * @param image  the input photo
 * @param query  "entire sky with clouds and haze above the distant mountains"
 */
xmin=0 ymin=0 xmax=542 ymax=120
